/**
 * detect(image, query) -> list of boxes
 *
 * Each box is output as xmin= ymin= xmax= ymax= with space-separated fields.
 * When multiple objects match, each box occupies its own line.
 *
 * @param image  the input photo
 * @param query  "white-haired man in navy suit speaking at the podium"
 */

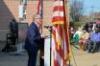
xmin=25 ymin=15 xmax=43 ymax=66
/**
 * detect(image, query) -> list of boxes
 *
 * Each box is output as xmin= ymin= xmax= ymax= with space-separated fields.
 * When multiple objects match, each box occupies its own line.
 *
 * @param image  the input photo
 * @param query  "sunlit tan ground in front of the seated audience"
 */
xmin=70 ymin=45 xmax=100 ymax=66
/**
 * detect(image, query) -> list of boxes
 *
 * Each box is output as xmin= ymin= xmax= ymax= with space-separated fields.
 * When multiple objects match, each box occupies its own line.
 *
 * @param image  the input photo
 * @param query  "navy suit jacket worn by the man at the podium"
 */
xmin=25 ymin=22 xmax=43 ymax=49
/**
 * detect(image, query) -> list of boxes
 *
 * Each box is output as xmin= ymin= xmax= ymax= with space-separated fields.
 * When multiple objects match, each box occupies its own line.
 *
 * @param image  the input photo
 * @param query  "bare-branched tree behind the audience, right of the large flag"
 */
xmin=70 ymin=0 xmax=83 ymax=22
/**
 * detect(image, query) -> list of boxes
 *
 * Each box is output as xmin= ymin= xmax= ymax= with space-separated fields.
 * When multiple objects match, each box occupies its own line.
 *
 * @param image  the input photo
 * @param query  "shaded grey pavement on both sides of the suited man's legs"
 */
xmin=0 ymin=42 xmax=40 ymax=66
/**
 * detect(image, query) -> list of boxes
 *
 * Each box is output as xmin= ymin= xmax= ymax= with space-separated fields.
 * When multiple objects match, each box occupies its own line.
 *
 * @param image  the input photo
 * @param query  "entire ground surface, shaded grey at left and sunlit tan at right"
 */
xmin=0 ymin=42 xmax=100 ymax=66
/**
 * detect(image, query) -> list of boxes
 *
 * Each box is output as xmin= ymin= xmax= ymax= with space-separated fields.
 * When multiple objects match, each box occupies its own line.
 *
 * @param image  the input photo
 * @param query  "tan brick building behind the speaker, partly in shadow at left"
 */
xmin=0 ymin=0 xmax=53 ymax=40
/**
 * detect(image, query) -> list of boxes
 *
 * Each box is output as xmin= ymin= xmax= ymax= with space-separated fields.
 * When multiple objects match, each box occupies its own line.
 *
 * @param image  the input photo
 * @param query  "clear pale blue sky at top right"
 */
xmin=70 ymin=0 xmax=100 ymax=15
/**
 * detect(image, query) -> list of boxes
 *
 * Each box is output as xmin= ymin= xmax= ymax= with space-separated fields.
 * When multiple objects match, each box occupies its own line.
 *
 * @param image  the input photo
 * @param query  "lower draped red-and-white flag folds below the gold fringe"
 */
xmin=52 ymin=25 xmax=67 ymax=66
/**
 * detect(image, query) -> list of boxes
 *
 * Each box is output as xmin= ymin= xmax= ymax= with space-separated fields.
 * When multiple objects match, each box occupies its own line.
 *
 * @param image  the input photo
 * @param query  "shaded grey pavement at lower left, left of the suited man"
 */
xmin=0 ymin=42 xmax=28 ymax=66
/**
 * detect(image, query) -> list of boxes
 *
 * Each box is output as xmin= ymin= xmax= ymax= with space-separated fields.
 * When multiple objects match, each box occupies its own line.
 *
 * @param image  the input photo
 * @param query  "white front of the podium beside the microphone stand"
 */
xmin=44 ymin=37 xmax=50 ymax=66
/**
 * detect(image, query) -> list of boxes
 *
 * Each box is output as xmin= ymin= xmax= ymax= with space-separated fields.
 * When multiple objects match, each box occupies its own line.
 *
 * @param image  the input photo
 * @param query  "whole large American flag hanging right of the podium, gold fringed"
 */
xmin=51 ymin=0 xmax=69 ymax=66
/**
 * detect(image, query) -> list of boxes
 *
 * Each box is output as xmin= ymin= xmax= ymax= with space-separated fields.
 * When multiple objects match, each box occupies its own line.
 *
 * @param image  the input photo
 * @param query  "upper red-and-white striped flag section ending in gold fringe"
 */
xmin=52 ymin=1 xmax=64 ymax=24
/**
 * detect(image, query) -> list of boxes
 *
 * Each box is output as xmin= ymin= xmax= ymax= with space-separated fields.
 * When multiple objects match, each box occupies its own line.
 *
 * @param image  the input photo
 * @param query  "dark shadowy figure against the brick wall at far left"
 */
xmin=2 ymin=19 xmax=18 ymax=52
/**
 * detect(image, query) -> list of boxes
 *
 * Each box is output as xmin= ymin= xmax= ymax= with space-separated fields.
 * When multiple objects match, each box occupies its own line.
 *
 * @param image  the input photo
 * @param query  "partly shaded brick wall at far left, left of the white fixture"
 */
xmin=0 ymin=0 xmax=19 ymax=40
